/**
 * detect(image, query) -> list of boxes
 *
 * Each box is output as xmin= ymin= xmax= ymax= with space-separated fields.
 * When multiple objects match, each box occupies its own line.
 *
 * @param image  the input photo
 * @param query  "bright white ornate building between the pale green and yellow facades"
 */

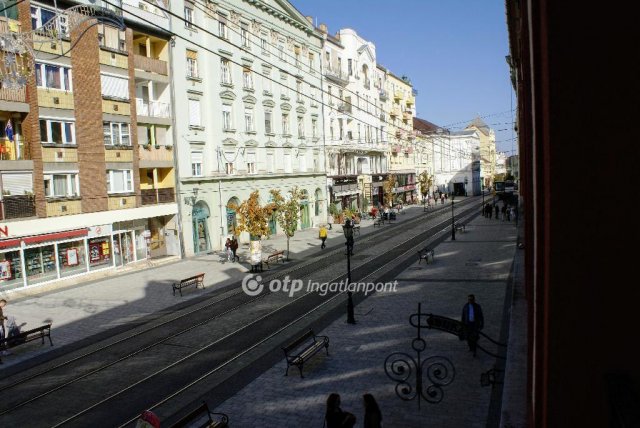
xmin=318 ymin=25 xmax=388 ymax=211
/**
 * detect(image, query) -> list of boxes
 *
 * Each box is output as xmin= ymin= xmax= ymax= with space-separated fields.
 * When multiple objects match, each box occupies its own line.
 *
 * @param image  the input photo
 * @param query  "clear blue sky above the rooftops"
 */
xmin=291 ymin=0 xmax=517 ymax=151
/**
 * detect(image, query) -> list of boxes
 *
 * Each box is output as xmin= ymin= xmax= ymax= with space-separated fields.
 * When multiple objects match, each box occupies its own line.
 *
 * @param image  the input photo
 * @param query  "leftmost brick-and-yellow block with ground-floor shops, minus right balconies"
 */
xmin=0 ymin=1 xmax=180 ymax=291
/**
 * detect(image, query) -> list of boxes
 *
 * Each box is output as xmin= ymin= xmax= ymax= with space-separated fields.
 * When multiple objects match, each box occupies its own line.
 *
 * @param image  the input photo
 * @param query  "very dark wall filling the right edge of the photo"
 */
xmin=518 ymin=0 xmax=640 ymax=427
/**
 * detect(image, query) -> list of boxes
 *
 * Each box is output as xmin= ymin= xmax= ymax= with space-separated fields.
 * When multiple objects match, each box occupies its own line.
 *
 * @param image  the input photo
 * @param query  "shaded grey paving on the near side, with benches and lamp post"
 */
xmin=216 ymin=217 xmax=516 ymax=428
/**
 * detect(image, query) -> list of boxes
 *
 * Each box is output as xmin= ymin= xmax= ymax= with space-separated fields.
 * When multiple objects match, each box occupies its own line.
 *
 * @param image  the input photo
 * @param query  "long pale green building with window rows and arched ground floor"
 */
xmin=171 ymin=0 xmax=327 ymax=255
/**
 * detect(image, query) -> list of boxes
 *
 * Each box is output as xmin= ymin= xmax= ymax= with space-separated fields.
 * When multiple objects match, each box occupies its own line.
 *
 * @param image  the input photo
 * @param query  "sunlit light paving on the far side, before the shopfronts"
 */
xmin=0 ymin=206 xmax=450 ymax=371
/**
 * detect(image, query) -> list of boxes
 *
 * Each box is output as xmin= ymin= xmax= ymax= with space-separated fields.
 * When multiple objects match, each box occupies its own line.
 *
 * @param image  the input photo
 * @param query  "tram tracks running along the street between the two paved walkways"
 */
xmin=0 ymin=200 xmax=479 ymax=426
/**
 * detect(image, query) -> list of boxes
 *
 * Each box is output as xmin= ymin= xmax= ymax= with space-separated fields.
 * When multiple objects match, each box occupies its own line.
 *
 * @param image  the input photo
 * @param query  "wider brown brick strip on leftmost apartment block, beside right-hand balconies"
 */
xmin=71 ymin=21 xmax=108 ymax=213
